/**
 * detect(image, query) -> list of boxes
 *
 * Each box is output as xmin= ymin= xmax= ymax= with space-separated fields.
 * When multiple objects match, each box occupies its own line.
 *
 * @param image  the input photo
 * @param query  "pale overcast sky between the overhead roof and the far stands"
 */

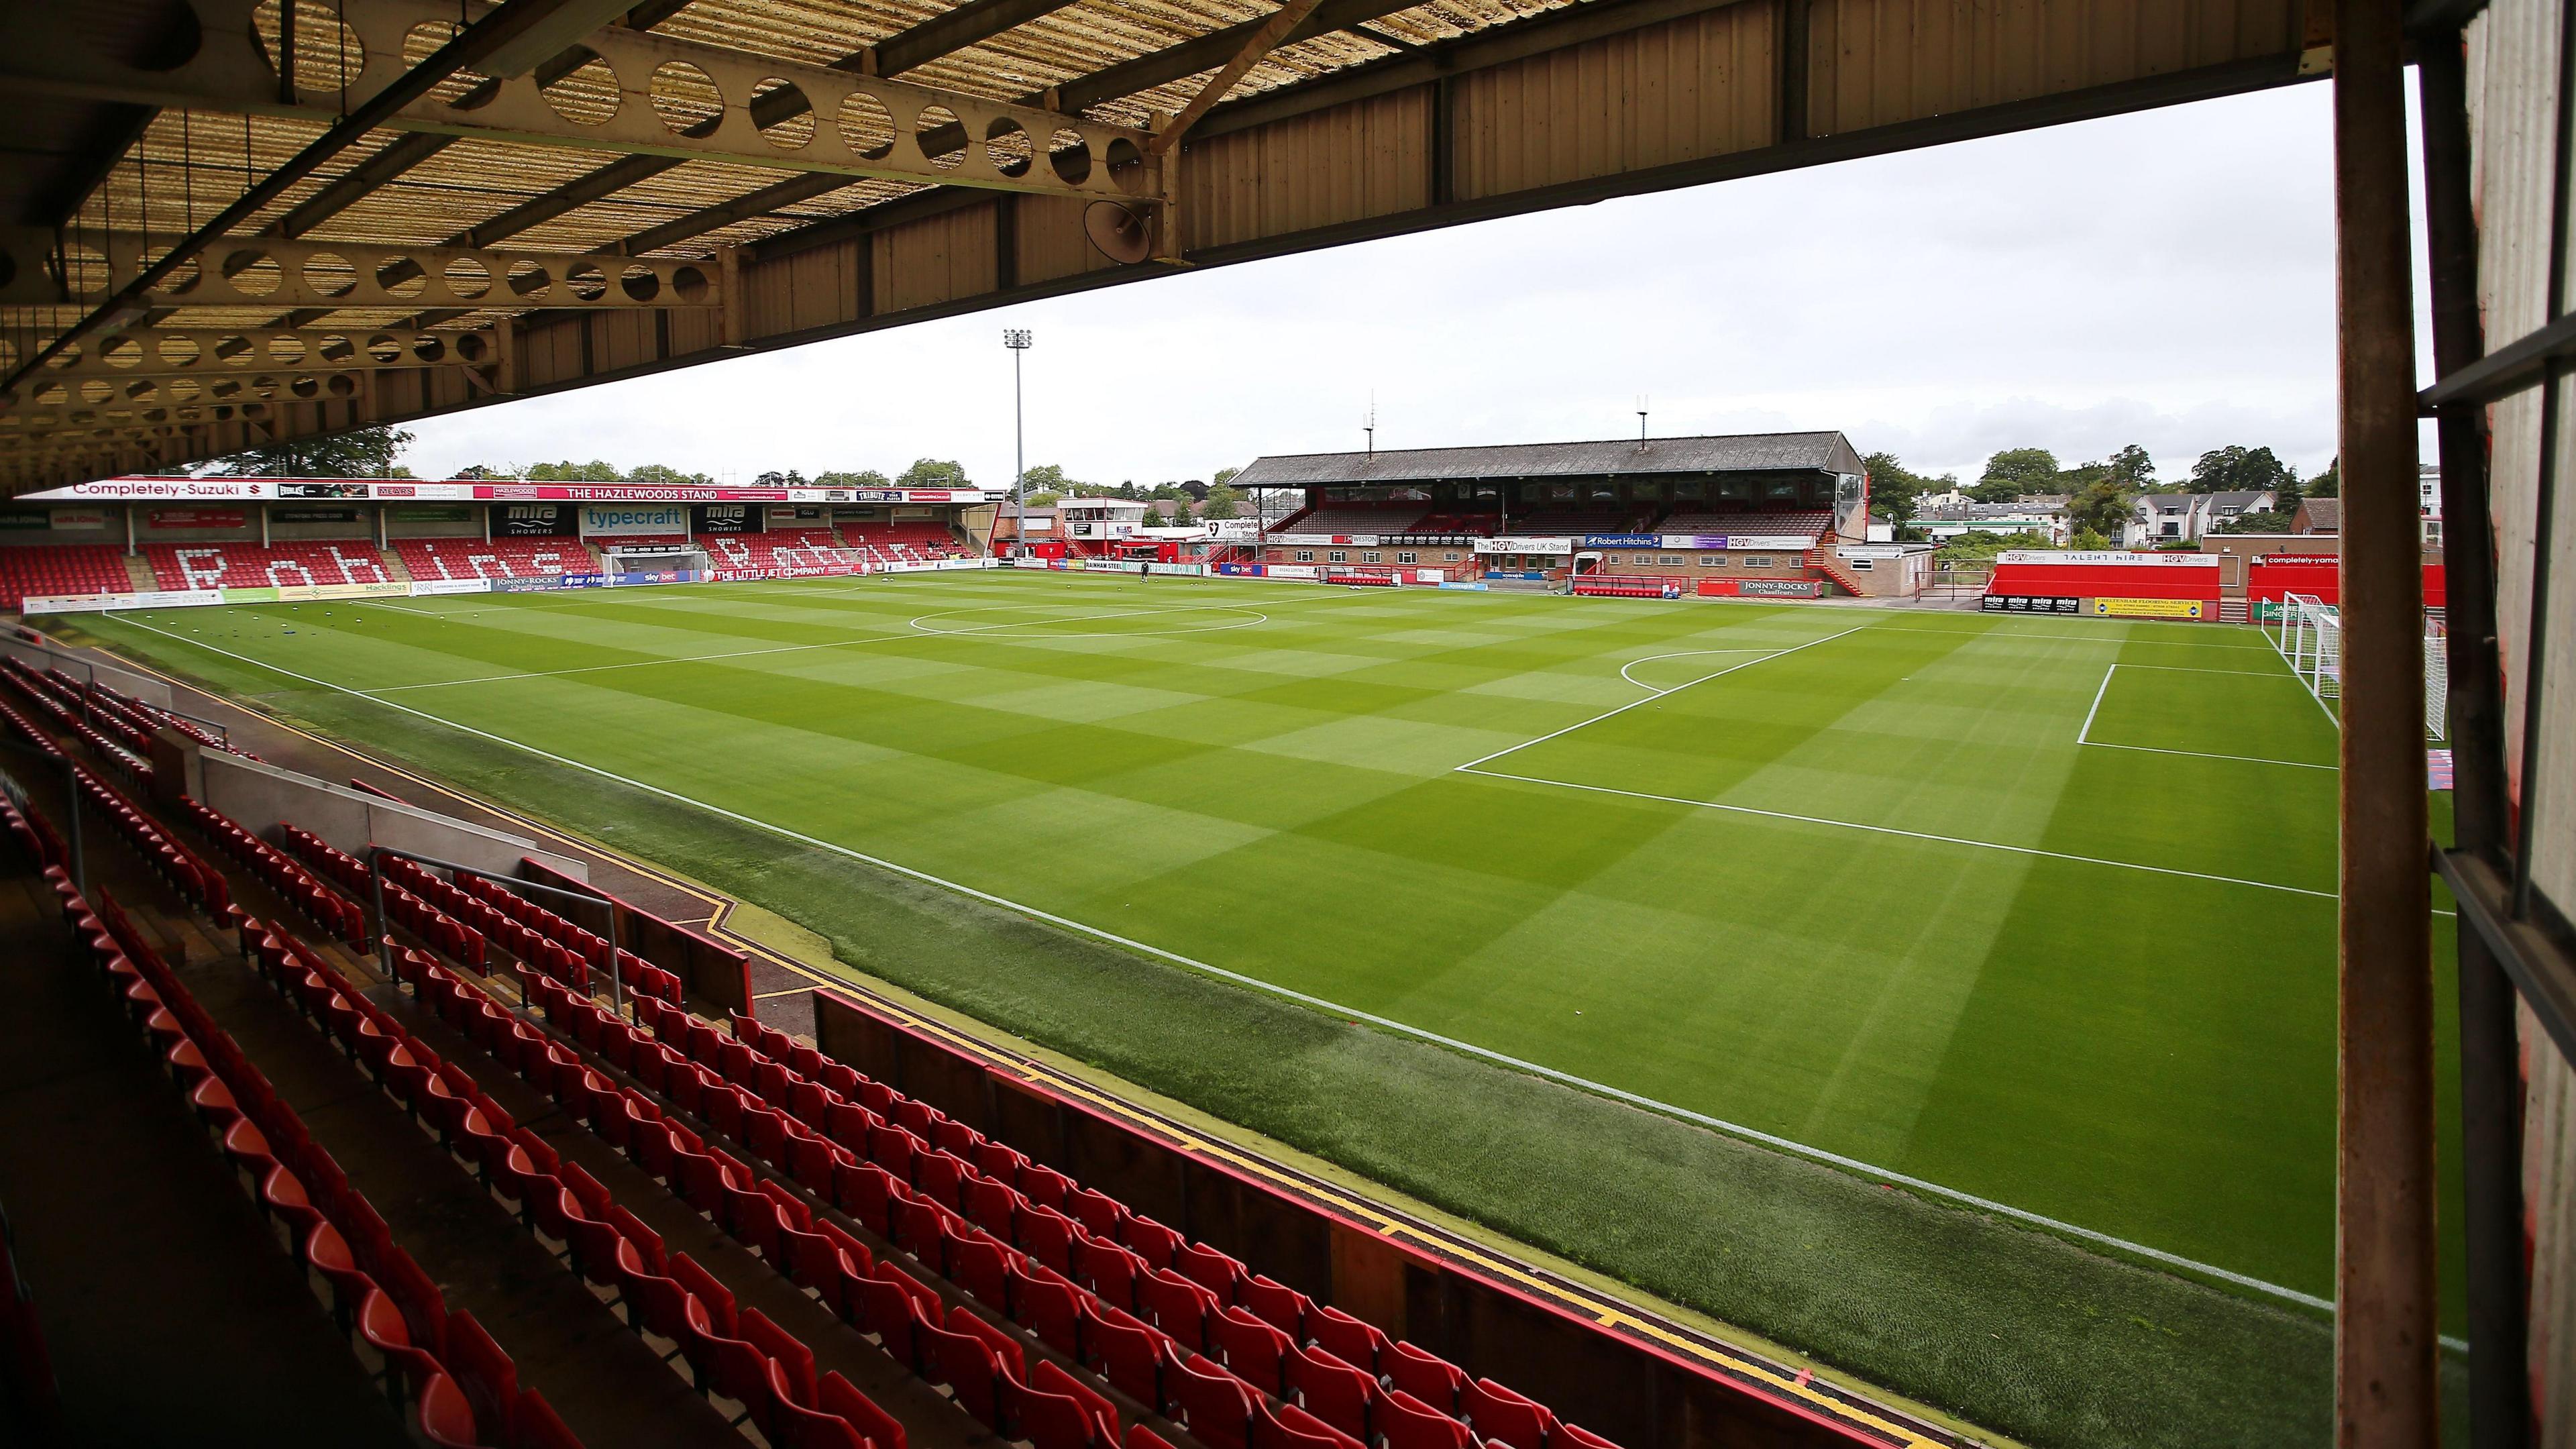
xmin=407 ymin=83 xmax=2426 ymax=485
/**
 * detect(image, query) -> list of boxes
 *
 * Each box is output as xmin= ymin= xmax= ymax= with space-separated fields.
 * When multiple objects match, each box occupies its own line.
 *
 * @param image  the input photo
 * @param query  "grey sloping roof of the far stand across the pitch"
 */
xmin=1226 ymin=433 xmax=1862 ymax=487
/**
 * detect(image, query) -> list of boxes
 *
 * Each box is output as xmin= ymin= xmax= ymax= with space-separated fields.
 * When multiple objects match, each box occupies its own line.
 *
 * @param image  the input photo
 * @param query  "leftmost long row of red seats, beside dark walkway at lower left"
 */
xmin=0 ymin=799 xmax=533 ymax=1449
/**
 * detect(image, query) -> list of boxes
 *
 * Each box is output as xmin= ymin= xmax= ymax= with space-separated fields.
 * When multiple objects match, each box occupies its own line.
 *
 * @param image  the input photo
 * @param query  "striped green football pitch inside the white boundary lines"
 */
xmin=83 ymin=559 xmax=2457 ymax=1330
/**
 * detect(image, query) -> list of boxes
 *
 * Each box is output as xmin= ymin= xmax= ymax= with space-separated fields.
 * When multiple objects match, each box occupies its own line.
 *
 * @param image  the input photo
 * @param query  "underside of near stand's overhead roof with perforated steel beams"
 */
xmin=0 ymin=0 xmax=2328 ymax=492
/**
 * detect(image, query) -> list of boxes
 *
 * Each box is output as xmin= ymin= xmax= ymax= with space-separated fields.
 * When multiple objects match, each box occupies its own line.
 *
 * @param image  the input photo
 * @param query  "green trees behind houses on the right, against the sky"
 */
xmin=1862 ymin=443 xmax=2342 ymax=549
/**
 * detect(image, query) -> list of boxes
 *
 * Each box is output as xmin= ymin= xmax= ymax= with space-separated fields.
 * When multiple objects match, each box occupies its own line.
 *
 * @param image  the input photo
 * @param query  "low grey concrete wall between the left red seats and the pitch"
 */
xmin=188 ymin=750 xmax=590 ymax=881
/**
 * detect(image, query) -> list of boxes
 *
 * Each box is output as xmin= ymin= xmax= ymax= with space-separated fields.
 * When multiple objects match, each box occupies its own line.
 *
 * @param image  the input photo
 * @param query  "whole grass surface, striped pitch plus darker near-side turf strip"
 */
xmin=65 ymin=575 xmax=2473 ymax=1444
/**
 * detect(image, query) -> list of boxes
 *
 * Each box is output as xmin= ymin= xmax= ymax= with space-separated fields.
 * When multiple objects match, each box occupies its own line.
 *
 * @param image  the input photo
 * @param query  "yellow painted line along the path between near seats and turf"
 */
xmin=101 ymin=650 xmax=1945 ymax=1449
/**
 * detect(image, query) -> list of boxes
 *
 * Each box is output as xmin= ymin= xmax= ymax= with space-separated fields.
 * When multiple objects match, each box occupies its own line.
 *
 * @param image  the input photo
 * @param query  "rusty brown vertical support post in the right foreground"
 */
xmin=2334 ymin=0 xmax=2439 ymax=1449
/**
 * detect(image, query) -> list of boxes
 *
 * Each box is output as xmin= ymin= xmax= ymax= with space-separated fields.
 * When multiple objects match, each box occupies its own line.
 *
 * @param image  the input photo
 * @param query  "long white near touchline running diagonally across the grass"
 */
xmin=105 ymin=608 xmax=2390 ymax=1312
